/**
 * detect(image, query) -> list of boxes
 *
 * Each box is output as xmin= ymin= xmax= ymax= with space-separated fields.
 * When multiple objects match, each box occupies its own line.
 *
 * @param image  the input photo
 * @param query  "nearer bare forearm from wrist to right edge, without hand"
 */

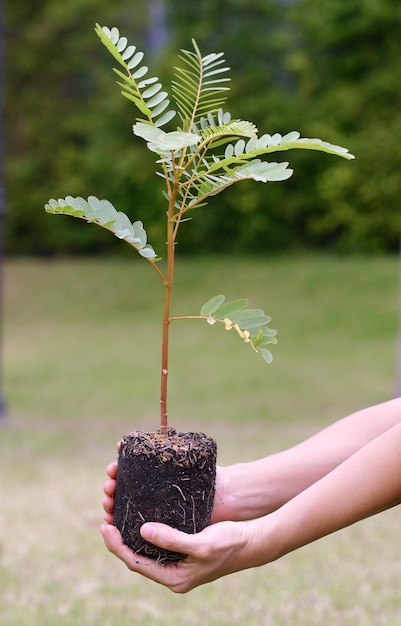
xmin=249 ymin=424 xmax=401 ymax=564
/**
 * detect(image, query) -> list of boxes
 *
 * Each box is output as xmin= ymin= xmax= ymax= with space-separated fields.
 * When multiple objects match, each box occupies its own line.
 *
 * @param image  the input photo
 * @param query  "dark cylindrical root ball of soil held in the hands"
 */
xmin=114 ymin=428 xmax=217 ymax=563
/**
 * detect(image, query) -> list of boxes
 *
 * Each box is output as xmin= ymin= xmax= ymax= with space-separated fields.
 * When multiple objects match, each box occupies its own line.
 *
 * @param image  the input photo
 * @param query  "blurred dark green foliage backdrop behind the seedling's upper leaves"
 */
xmin=6 ymin=0 xmax=401 ymax=254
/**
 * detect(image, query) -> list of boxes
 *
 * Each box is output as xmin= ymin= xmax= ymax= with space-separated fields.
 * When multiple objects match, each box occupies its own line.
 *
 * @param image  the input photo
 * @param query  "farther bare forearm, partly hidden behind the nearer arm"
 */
xmin=222 ymin=399 xmax=401 ymax=520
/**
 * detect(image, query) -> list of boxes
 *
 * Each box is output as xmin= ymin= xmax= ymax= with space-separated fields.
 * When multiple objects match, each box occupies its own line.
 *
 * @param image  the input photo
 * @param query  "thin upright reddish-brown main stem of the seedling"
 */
xmin=160 ymin=178 xmax=178 ymax=432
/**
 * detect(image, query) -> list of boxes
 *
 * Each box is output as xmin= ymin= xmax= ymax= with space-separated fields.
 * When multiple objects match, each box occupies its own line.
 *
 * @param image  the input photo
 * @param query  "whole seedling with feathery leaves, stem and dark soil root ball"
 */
xmin=45 ymin=24 xmax=354 ymax=562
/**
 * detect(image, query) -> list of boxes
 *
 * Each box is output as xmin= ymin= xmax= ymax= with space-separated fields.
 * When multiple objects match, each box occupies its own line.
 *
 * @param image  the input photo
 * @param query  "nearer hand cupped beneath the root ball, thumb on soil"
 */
xmin=101 ymin=520 xmax=252 ymax=593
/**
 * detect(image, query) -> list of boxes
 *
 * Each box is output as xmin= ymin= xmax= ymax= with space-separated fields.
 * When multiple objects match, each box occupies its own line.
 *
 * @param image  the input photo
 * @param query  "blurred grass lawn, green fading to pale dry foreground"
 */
xmin=0 ymin=256 xmax=401 ymax=626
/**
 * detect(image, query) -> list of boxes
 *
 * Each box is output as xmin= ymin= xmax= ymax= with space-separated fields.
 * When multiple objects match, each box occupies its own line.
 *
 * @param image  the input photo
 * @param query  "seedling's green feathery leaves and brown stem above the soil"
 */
xmin=45 ymin=24 xmax=354 ymax=431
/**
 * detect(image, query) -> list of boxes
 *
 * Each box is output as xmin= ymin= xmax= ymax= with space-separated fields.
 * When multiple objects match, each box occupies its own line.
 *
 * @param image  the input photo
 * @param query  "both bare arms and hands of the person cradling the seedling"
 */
xmin=102 ymin=400 xmax=401 ymax=593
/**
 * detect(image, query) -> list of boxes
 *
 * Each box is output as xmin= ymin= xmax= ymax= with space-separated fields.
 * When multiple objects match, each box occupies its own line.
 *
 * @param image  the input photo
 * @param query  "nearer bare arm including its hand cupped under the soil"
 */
xmin=102 ymin=424 xmax=401 ymax=593
